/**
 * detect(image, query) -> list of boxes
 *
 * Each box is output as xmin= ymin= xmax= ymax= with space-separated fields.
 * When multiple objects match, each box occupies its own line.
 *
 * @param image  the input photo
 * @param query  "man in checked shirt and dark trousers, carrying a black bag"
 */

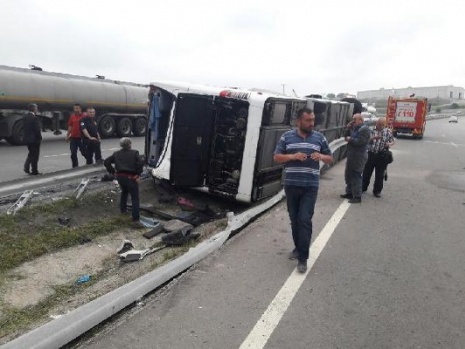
xmin=362 ymin=117 xmax=394 ymax=198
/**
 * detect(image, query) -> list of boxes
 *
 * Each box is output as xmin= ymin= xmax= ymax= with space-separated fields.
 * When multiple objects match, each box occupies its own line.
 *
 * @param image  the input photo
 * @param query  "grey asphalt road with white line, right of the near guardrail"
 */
xmin=73 ymin=119 xmax=465 ymax=349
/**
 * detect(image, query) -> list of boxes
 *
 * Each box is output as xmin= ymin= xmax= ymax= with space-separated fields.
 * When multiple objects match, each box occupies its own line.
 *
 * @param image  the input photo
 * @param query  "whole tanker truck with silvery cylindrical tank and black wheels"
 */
xmin=0 ymin=65 xmax=149 ymax=145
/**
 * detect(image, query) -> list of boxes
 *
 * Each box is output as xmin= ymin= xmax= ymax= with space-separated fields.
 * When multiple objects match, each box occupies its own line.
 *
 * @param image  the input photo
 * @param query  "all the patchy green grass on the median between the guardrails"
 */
xmin=0 ymin=188 xmax=207 ymax=338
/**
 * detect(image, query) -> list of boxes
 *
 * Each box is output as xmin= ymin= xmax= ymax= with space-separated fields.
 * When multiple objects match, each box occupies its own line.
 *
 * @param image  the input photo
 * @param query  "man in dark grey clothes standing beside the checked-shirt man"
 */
xmin=341 ymin=114 xmax=370 ymax=204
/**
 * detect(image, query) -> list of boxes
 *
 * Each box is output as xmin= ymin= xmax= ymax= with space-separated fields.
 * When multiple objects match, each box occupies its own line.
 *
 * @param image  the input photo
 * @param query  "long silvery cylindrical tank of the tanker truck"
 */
xmin=0 ymin=65 xmax=148 ymax=113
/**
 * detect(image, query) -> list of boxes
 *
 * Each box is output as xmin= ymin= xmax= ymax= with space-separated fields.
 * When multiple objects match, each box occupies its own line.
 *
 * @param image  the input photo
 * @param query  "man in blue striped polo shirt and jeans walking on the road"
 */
xmin=273 ymin=108 xmax=333 ymax=273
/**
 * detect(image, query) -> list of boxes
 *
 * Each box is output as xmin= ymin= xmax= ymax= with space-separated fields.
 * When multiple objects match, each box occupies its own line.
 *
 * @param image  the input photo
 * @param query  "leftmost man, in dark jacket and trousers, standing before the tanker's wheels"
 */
xmin=23 ymin=103 xmax=42 ymax=175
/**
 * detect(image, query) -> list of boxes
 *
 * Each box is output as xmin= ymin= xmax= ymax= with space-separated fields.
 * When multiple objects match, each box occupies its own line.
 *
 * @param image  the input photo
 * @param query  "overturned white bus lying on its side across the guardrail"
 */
xmin=145 ymin=82 xmax=352 ymax=203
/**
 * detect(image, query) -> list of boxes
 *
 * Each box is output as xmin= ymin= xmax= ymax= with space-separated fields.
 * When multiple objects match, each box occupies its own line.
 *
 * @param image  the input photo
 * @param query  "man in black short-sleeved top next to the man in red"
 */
xmin=81 ymin=107 xmax=102 ymax=165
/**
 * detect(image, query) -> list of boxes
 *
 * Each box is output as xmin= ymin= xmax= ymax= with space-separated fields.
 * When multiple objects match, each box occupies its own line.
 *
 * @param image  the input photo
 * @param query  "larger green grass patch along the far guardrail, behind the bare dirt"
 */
xmin=0 ymin=194 xmax=123 ymax=278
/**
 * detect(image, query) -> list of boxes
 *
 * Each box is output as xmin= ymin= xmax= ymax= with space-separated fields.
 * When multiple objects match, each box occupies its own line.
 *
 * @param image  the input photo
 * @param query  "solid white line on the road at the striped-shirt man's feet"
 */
xmin=239 ymin=200 xmax=350 ymax=349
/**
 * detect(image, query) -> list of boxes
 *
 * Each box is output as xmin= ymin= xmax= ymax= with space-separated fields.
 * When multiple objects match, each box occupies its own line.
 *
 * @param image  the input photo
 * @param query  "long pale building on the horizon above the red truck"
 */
xmin=357 ymin=85 xmax=465 ymax=101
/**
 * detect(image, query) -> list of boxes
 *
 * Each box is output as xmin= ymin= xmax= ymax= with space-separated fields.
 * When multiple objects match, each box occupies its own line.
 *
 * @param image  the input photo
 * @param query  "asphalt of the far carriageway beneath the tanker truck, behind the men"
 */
xmin=0 ymin=131 xmax=144 ymax=182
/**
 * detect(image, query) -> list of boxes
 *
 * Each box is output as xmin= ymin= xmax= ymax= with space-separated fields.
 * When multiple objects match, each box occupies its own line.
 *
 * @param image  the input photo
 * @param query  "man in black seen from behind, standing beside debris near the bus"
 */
xmin=103 ymin=137 xmax=144 ymax=228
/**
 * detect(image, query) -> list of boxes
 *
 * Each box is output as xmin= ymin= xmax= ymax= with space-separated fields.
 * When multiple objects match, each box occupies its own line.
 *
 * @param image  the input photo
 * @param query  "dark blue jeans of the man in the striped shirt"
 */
xmin=284 ymin=185 xmax=318 ymax=261
